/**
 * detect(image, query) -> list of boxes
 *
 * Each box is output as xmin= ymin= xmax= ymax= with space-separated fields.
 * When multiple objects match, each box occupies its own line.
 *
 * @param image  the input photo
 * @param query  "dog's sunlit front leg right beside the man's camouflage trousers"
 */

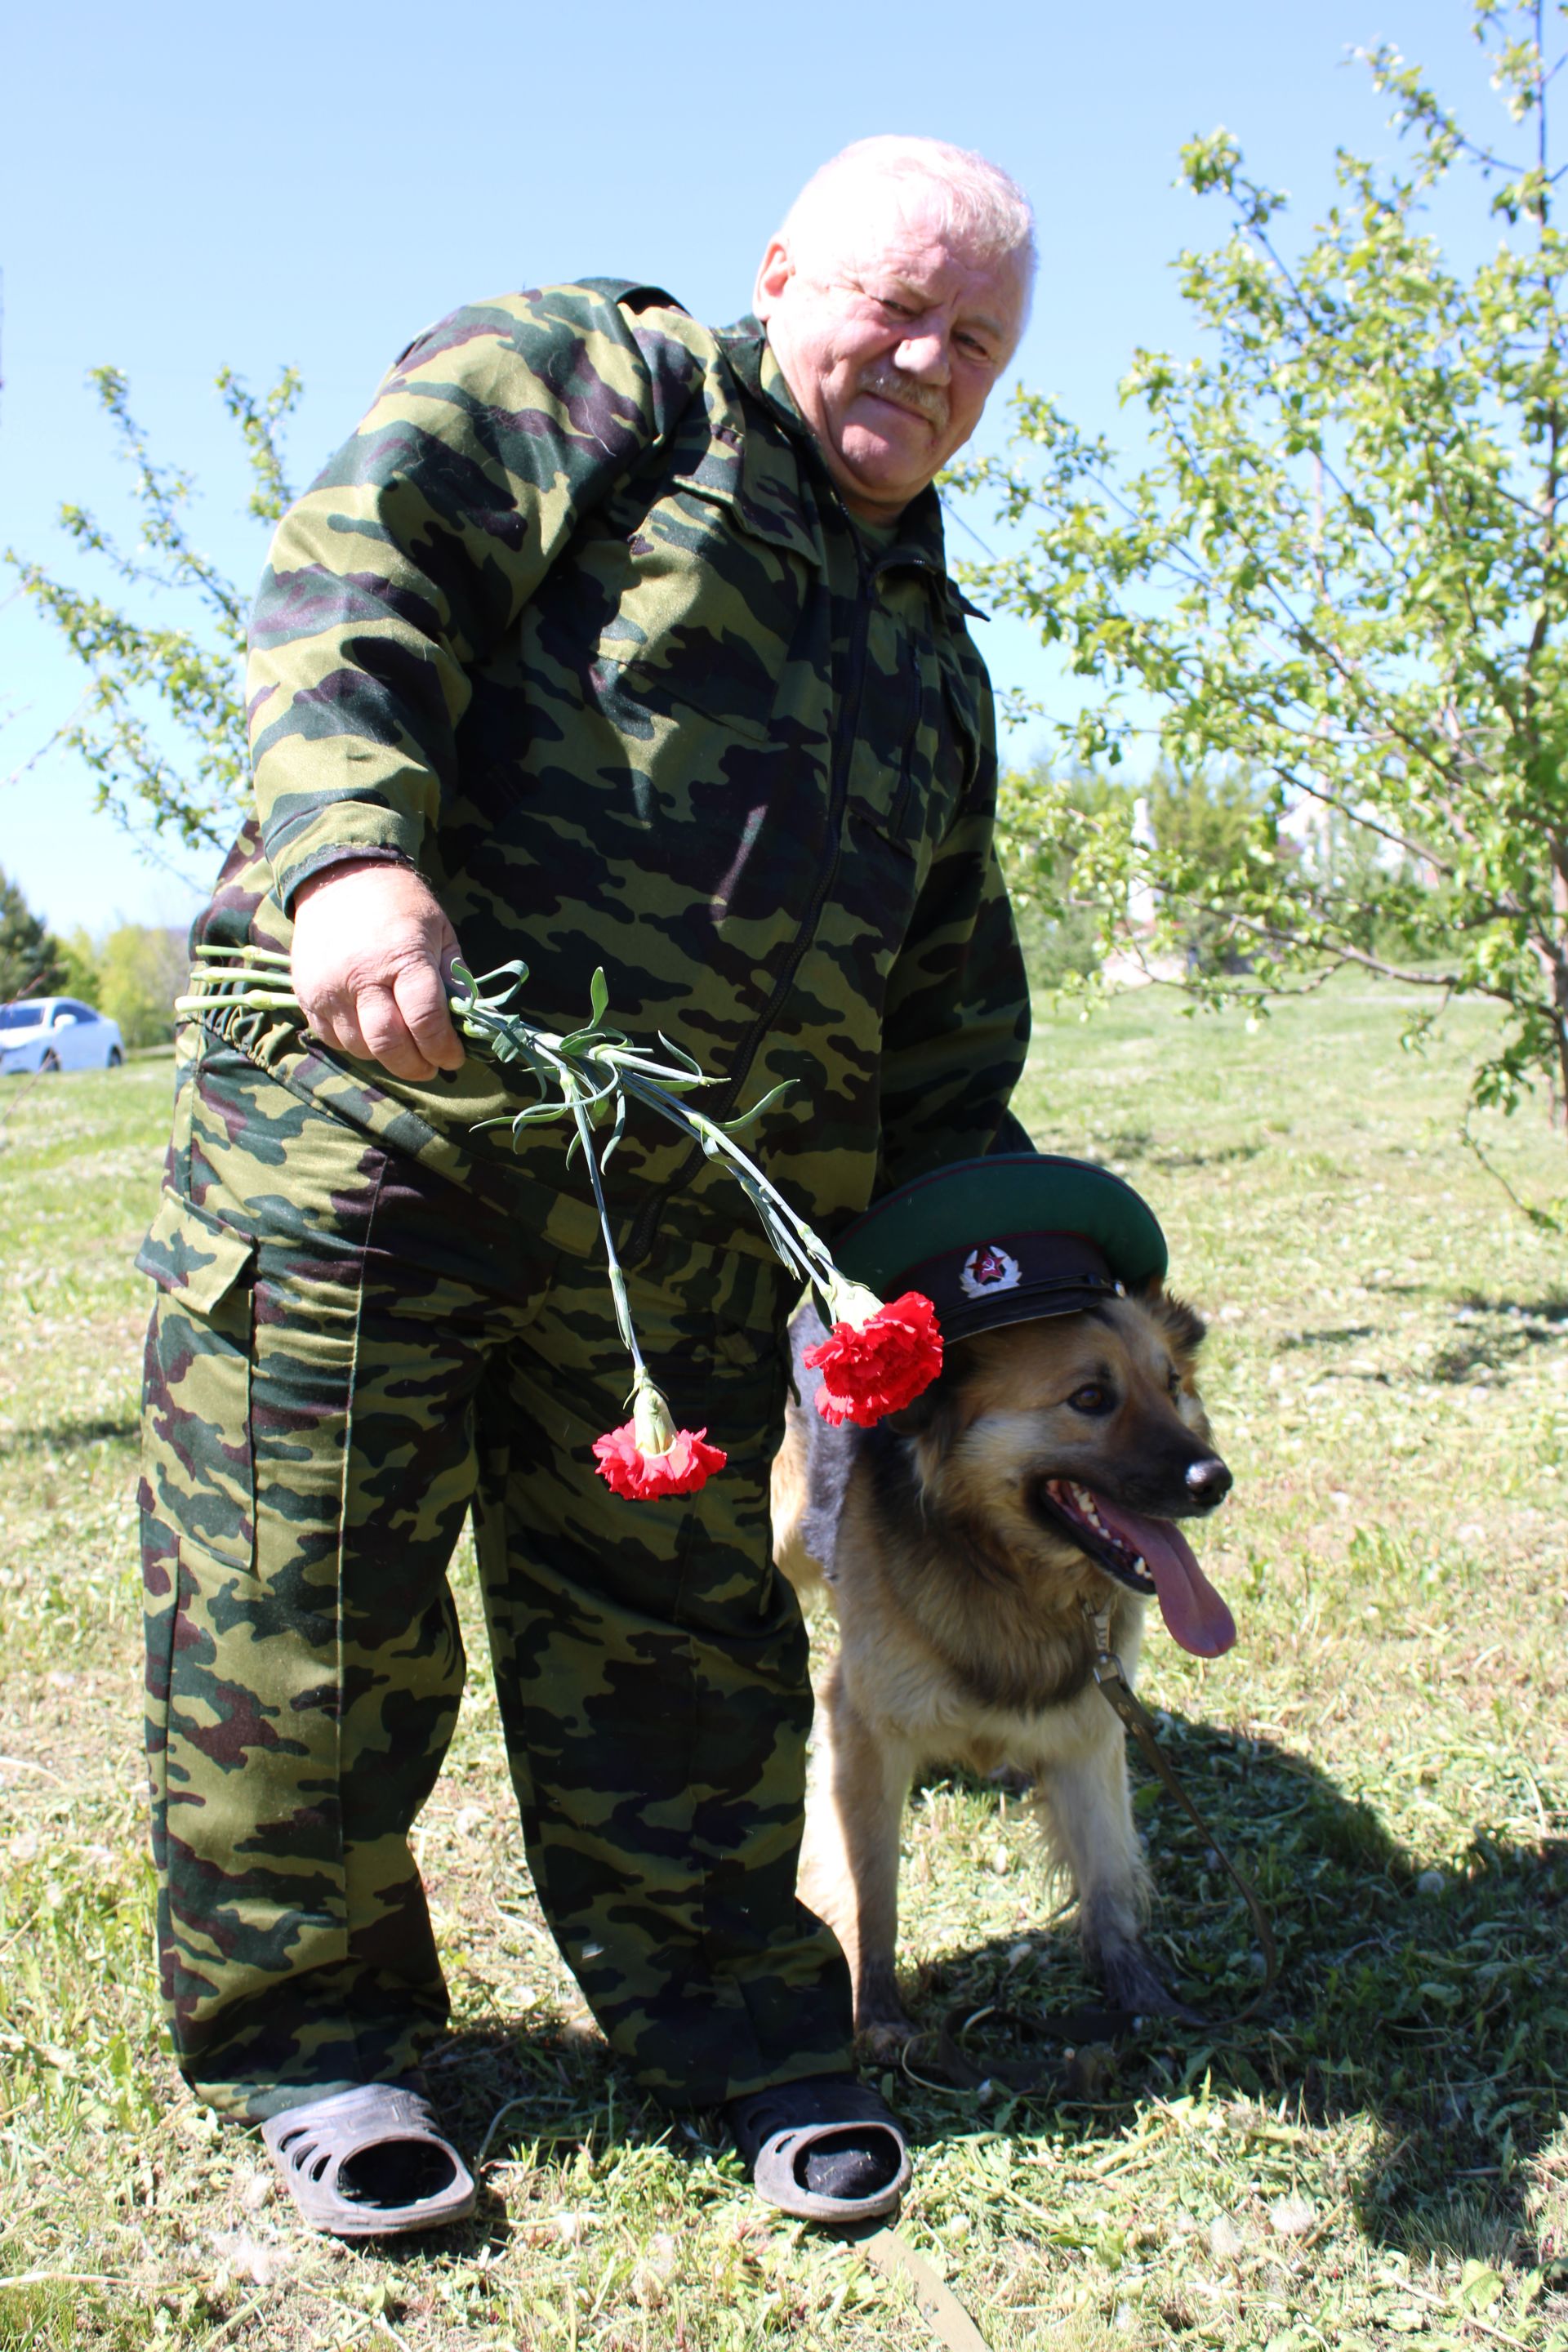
xmin=800 ymin=1656 xmax=917 ymax=2042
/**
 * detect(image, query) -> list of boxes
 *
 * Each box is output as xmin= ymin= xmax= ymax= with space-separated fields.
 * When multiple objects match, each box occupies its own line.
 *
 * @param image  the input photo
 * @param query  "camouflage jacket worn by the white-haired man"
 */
xmin=195 ymin=284 xmax=1027 ymax=1256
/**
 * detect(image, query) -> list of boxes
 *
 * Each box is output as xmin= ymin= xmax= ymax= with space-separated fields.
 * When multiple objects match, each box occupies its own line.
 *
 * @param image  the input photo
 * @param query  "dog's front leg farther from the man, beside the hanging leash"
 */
xmin=1035 ymin=1691 xmax=1190 ymax=2016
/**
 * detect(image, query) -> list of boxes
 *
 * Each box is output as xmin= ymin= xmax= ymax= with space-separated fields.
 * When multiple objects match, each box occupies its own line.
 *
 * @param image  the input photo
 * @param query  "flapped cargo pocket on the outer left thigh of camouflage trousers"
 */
xmin=136 ymin=1192 xmax=256 ymax=1569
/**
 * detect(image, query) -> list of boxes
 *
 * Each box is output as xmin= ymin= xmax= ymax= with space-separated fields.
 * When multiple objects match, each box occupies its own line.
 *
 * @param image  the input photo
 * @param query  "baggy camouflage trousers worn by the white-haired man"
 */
xmin=139 ymin=1042 xmax=851 ymax=2114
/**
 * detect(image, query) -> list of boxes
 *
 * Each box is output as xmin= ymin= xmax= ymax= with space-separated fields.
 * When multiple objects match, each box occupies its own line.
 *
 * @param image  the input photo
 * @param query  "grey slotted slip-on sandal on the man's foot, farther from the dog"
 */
xmin=261 ymin=2082 xmax=477 ymax=2237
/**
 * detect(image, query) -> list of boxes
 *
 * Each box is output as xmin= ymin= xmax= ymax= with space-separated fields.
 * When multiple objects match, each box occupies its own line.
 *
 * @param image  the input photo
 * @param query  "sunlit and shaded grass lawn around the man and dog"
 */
xmin=0 ymin=988 xmax=1568 ymax=2352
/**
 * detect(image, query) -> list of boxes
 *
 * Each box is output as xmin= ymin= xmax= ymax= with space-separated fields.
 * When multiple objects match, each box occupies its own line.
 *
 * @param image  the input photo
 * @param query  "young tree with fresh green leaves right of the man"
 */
xmin=969 ymin=7 xmax=1568 ymax=1138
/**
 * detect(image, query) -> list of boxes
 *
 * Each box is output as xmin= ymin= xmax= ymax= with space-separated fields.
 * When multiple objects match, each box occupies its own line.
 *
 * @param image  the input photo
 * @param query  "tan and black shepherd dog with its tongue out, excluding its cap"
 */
xmin=773 ymin=1289 xmax=1234 ymax=2044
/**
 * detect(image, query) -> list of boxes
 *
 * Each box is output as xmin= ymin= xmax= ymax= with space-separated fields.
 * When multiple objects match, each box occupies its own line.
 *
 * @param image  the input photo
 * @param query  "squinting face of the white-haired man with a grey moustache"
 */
xmin=757 ymin=186 xmax=1025 ymax=522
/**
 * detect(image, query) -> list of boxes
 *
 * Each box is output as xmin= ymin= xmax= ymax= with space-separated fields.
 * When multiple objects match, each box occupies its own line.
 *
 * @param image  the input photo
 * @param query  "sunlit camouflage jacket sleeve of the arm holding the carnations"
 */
xmin=247 ymin=287 xmax=696 ymax=908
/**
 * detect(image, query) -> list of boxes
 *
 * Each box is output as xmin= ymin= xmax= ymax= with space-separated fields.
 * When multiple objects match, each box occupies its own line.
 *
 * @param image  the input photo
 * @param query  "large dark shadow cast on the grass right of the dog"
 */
xmin=917 ymin=1717 xmax=1568 ymax=2283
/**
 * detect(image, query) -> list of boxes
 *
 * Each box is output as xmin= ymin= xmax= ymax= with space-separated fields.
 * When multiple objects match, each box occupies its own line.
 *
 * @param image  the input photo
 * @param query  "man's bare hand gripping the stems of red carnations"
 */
xmin=292 ymin=858 xmax=463 ymax=1080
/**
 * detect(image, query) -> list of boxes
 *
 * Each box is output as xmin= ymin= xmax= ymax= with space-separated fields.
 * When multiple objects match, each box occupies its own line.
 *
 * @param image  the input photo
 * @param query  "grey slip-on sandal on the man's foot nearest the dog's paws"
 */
xmin=724 ymin=2074 xmax=910 ymax=2225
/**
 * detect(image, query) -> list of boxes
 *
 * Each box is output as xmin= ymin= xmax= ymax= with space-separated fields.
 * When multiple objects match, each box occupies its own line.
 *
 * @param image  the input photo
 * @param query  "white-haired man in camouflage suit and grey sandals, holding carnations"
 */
xmin=141 ymin=139 xmax=1032 ymax=2234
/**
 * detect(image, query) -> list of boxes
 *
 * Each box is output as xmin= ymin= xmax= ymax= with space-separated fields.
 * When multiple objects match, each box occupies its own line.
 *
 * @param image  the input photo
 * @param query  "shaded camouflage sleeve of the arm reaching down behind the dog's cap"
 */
xmin=877 ymin=647 xmax=1035 ymax=1192
